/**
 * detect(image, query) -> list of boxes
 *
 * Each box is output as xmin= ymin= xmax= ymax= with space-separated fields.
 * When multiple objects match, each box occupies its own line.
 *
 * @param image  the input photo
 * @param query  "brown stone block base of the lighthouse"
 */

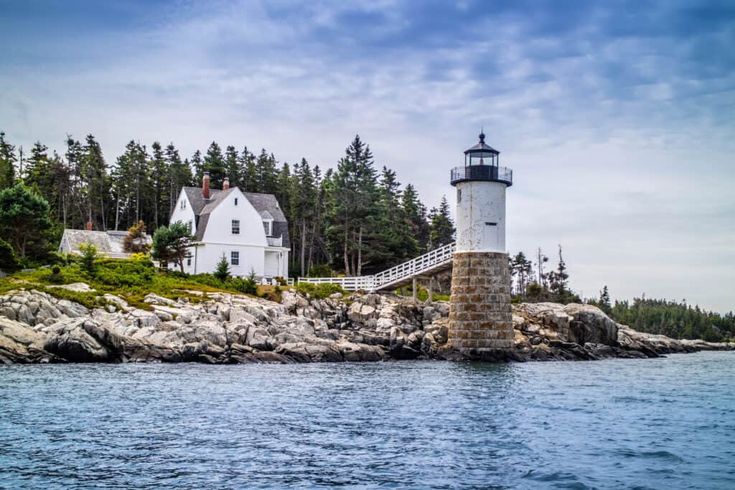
xmin=448 ymin=252 xmax=514 ymax=361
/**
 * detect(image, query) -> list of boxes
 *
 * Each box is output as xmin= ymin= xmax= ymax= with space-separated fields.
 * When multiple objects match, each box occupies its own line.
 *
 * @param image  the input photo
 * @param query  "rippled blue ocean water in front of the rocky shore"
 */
xmin=0 ymin=352 xmax=735 ymax=489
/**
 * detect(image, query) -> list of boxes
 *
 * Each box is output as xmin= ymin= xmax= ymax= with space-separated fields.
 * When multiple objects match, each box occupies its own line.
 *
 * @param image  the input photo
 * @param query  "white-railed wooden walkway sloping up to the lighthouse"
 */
xmin=298 ymin=243 xmax=455 ymax=291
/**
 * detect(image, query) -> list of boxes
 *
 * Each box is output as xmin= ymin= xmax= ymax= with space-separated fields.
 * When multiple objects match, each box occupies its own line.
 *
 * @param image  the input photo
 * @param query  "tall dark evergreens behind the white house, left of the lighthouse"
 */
xmin=0 ymin=133 xmax=454 ymax=275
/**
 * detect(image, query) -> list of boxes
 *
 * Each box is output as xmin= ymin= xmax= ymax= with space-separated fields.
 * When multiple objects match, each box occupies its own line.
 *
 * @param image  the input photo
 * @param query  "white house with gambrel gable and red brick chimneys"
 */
xmin=171 ymin=173 xmax=290 ymax=278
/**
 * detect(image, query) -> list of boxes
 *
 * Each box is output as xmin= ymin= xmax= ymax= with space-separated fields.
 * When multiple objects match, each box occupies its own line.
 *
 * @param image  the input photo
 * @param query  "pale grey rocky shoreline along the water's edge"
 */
xmin=0 ymin=285 xmax=735 ymax=364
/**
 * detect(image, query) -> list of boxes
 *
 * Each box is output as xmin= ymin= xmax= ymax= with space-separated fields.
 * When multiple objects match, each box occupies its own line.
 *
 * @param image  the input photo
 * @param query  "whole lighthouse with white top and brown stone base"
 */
xmin=449 ymin=132 xmax=514 ymax=360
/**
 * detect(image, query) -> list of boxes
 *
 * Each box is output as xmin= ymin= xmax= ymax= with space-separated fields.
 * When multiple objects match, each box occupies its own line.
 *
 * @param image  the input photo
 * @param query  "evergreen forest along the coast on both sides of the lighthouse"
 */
xmin=0 ymin=132 xmax=735 ymax=341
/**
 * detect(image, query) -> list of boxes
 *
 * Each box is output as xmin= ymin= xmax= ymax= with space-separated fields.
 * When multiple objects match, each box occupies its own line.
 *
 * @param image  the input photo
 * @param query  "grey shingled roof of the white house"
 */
xmin=184 ymin=187 xmax=289 ymax=247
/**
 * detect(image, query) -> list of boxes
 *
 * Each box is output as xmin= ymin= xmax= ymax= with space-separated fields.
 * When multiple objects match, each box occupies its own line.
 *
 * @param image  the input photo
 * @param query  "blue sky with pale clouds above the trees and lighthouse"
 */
xmin=0 ymin=0 xmax=735 ymax=312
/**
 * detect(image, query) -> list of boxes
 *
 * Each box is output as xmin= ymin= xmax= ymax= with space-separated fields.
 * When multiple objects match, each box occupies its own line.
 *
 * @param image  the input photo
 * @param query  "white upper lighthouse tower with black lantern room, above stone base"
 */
xmin=451 ymin=133 xmax=513 ymax=252
